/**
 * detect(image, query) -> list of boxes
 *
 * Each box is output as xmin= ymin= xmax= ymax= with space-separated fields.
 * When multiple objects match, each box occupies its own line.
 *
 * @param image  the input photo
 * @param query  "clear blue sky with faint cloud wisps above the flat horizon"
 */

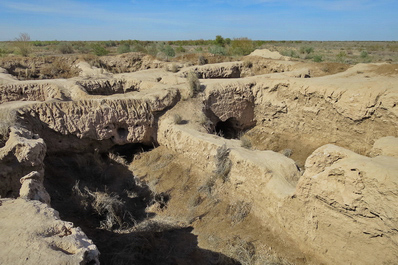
xmin=0 ymin=0 xmax=398 ymax=41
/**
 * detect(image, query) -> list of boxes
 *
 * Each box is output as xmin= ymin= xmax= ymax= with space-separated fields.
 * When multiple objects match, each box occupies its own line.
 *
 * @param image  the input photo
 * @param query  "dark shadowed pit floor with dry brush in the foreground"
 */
xmin=44 ymin=145 xmax=239 ymax=264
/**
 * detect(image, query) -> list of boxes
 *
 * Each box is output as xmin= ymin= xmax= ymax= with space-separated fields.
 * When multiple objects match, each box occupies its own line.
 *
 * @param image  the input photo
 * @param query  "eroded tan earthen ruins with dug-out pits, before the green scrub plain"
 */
xmin=0 ymin=50 xmax=398 ymax=264
